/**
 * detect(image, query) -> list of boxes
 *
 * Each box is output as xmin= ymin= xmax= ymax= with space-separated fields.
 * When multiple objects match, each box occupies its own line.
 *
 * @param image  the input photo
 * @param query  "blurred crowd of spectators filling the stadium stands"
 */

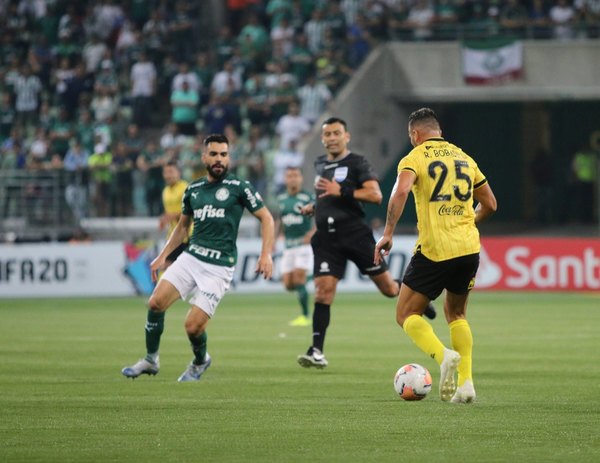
xmin=0 ymin=0 xmax=600 ymax=224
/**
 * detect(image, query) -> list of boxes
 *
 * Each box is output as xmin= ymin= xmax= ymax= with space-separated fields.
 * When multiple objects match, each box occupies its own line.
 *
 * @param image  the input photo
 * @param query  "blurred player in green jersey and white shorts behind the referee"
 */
xmin=275 ymin=167 xmax=315 ymax=326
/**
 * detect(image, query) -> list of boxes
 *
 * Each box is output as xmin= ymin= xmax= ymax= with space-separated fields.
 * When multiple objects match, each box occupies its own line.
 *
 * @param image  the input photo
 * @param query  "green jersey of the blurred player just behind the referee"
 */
xmin=277 ymin=191 xmax=315 ymax=248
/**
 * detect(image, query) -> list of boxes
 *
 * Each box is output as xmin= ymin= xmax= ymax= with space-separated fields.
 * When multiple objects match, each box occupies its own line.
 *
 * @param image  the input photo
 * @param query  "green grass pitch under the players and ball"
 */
xmin=0 ymin=291 xmax=600 ymax=463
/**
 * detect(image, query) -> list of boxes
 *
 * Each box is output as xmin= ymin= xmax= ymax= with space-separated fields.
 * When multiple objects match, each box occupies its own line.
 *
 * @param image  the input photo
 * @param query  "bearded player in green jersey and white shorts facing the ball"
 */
xmin=121 ymin=134 xmax=274 ymax=382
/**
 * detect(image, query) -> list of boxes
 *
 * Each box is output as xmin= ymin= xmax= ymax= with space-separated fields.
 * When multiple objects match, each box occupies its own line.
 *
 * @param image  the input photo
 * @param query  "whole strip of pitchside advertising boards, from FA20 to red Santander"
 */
xmin=0 ymin=236 xmax=600 ymax=305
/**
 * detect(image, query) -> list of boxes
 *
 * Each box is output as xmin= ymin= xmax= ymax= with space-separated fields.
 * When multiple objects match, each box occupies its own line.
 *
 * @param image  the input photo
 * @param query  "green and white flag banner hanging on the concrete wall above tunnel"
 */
xmin=462 ymin=40 xmax=523 ymax=85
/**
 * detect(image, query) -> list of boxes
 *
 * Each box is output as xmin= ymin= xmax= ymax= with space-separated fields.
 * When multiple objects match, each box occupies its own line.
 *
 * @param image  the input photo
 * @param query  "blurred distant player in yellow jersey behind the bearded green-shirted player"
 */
xmin=159 ymin=161 xmax=188 ymax=267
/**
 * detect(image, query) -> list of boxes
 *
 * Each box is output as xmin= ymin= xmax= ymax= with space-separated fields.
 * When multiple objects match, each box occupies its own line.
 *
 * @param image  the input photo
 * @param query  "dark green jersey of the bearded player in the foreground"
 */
xmin=182 ymin=174 xmax=264 ymax=267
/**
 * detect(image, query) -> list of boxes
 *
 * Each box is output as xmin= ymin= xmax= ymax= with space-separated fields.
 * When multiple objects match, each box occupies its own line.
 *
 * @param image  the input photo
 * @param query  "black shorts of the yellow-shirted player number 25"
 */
xmin=402 ymin=252 xmax=479 ymax=300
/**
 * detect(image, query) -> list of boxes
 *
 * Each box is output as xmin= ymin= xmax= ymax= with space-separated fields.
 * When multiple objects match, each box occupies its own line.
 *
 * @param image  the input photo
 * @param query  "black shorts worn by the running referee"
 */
xmin=310 ymin=225 xmax=388 ymax=280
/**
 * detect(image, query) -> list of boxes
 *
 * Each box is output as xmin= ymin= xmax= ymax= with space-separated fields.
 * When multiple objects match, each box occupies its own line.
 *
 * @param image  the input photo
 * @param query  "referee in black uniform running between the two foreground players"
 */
xmin=298 ymin=117 xmax=435 ymax=368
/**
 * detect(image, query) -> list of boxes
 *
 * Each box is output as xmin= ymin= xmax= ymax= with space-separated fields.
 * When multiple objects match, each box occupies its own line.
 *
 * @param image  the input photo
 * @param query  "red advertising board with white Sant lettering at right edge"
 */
xmin=475 ymin=238 xmax=600 ymax=291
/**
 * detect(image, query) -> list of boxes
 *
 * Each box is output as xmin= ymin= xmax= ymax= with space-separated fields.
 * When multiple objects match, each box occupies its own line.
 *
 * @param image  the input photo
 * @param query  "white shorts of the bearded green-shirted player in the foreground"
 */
xmin=161 ymin=252 xmax=234 ymax=317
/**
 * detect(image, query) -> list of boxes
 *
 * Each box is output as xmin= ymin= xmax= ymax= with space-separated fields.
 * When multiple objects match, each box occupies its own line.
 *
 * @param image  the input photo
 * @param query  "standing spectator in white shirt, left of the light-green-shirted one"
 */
xmin=130 ymin=51 xmax=157 ymax=127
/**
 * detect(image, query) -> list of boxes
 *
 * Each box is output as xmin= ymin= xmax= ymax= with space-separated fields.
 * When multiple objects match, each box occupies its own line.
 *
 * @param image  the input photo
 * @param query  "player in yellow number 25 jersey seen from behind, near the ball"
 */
xmin=374 ymin=108 xmax=496 ymax=403
